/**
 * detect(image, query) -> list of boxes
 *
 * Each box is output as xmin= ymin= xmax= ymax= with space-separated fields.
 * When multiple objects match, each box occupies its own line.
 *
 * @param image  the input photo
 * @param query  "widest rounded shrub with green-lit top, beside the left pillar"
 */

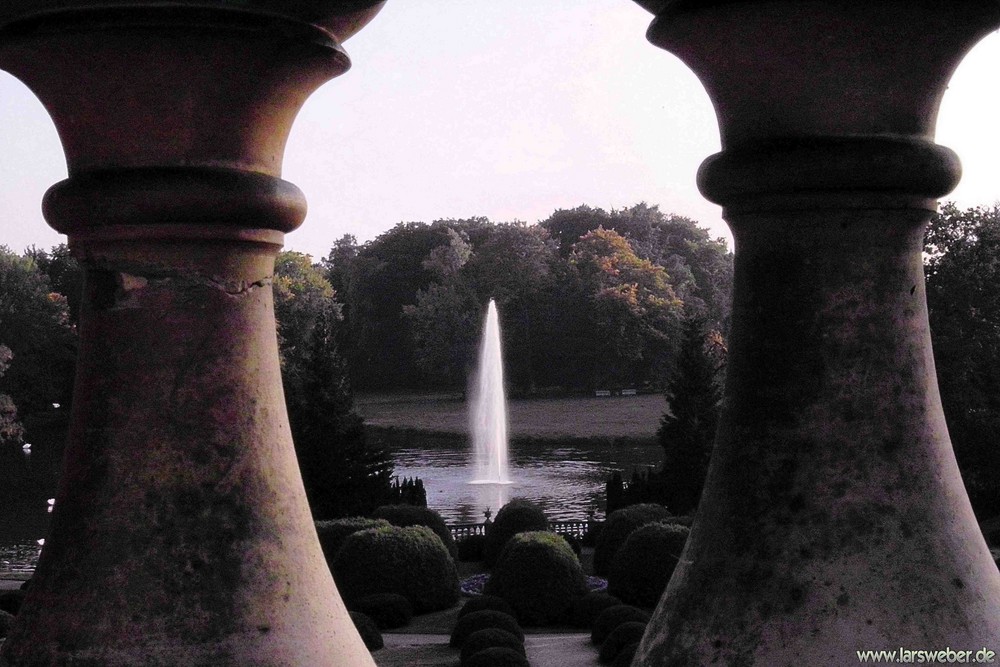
xmin=333 ymin=526 xmax=459 ymax=614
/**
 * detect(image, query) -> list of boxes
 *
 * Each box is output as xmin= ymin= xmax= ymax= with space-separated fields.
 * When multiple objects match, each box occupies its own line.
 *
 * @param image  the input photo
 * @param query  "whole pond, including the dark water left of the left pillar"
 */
xmin=0 ymin=420 xmax=662 ymax=573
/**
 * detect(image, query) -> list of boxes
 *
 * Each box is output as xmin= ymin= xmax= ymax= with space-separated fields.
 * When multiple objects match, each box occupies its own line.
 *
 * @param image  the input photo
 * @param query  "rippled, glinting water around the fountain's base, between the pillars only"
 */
xmin=391 ymin=442 xmax=663 ymax=523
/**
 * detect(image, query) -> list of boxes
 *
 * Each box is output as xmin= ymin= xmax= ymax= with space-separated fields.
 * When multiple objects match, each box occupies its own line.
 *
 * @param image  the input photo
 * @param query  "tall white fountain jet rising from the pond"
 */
xmin=469 ymin=299 xmax=511 ymax=484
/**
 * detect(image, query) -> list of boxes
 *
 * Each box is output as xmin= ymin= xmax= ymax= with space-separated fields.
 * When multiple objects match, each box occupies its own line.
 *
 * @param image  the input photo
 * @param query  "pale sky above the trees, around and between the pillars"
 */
xmin=0 ymin=0 xmax=1000 ymax=258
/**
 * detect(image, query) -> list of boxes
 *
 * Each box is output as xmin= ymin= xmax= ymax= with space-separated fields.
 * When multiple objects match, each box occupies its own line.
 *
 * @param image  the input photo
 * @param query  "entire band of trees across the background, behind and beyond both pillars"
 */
xmin=7 ymin=197 xmax=1000 ymax=519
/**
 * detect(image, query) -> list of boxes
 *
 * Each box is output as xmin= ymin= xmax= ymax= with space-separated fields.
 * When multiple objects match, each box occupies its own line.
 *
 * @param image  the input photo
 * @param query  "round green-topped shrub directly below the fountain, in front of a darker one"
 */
xmin=483 ymin=532 xmax=587 ymax=625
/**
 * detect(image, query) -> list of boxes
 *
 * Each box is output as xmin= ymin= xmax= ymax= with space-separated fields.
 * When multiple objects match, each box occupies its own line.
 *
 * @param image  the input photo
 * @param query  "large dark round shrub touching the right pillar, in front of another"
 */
xmin=608 ymin=523 xmax=691 ymax=607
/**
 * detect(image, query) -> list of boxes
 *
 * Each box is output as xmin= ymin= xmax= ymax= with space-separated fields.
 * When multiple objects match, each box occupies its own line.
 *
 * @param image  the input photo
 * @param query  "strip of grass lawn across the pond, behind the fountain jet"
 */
xmin=356 ymin=394 xmax=667 ymax=439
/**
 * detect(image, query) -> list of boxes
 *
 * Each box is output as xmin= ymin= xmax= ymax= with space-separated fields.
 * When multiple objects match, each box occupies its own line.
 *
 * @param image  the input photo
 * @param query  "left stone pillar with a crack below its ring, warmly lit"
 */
xmin=0 ymin=0 xmax=381 ymax=666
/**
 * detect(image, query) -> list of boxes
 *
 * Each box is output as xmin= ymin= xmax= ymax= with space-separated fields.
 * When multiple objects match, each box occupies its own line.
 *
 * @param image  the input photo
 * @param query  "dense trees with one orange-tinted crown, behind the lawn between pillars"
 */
xmin=324 ymin=204 xmax=732 ymax=393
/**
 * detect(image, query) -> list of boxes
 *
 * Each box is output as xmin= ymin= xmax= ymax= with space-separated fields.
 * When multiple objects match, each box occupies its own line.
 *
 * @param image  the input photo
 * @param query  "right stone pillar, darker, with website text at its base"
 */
xmin=634 ymin=0 xmax=1000 ymax=667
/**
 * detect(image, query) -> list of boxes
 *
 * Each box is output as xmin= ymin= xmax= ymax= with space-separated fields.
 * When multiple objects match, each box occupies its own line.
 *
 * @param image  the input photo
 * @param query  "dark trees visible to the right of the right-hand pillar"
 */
xmin=924 ymin=204 xmax=1000 ymax=519
